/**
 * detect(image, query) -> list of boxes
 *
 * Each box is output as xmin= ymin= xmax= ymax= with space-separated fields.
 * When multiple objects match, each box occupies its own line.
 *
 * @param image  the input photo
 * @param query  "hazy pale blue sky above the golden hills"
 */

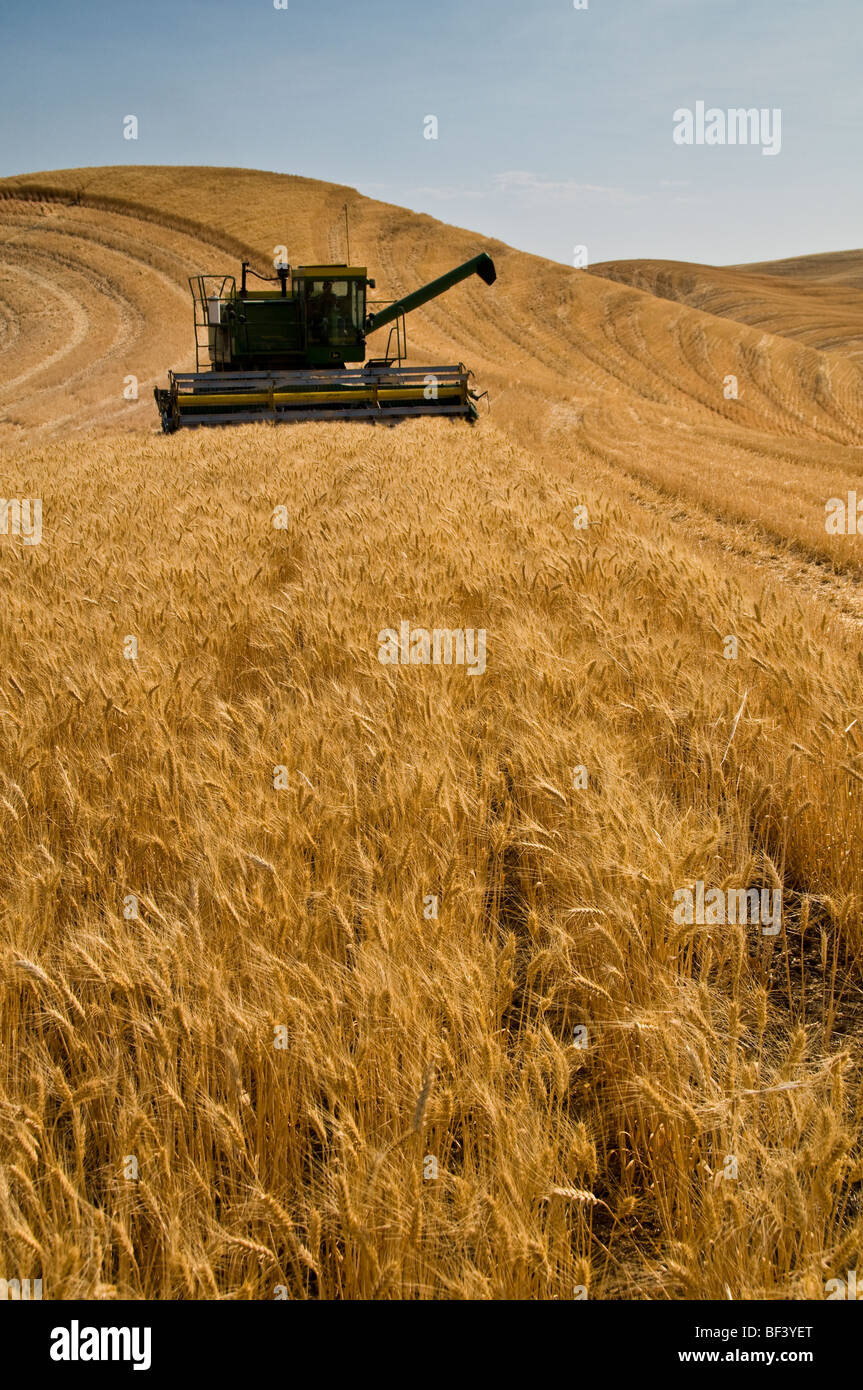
xmin=0 ymin=0 xmax=863 ymax=264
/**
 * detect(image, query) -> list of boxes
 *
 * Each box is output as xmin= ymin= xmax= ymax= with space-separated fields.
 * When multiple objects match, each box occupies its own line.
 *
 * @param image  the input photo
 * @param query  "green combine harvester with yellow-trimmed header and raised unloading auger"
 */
xmin=156 ymin=253 xmax=496 ymax=434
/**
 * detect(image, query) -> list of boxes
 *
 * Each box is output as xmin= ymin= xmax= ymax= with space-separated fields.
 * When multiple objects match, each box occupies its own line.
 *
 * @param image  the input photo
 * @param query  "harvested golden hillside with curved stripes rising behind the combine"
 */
xmin=0 ymin=168 xmax=863 ymax=581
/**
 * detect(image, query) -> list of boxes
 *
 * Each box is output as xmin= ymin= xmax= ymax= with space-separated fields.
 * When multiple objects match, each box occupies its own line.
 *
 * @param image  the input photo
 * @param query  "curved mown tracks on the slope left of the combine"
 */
xmin=0 ymin=196 xmax=232 ymax=435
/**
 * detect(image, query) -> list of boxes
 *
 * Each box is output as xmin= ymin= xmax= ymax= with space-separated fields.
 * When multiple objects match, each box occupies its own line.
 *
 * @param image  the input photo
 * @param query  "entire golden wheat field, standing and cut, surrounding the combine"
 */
xmin=0 ymin=168 xmax=863 ymax=1300
